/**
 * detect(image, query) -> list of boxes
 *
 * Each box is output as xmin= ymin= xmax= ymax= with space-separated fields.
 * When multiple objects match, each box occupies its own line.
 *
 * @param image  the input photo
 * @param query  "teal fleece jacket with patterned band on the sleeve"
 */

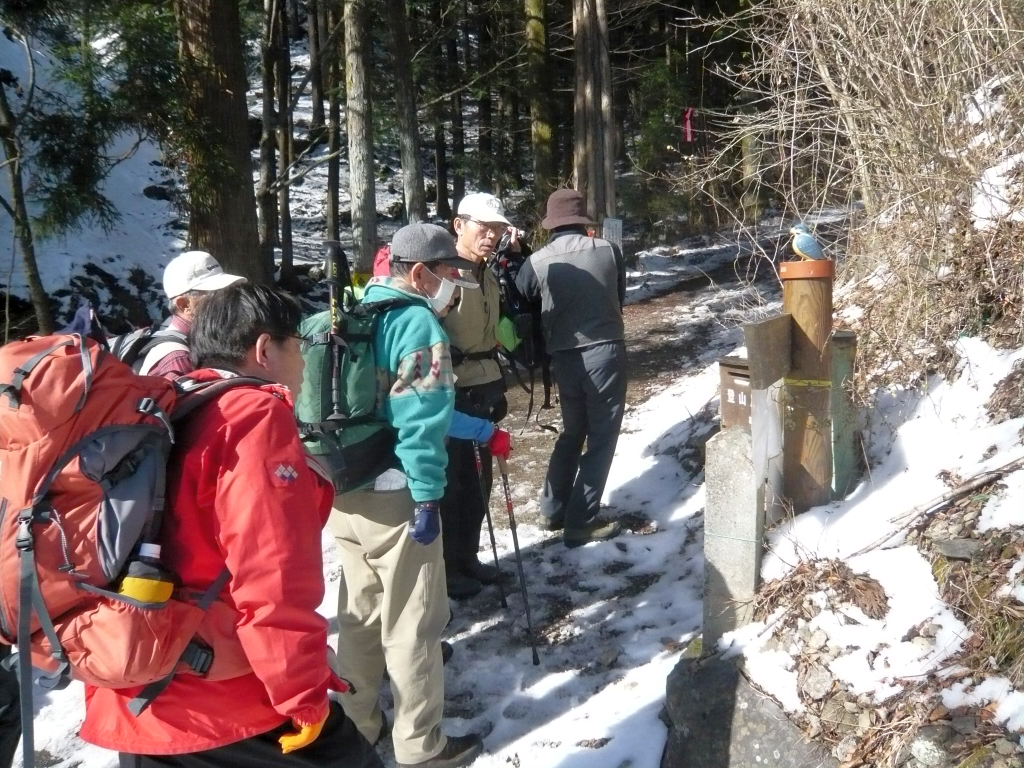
xmin=362 ymin=278 xmax=455 ymax=502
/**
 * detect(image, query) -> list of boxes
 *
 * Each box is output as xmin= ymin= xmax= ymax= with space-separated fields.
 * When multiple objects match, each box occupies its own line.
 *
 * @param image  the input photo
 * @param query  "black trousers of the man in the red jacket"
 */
xmin=118 ymin=701 xmax=384 ymax=768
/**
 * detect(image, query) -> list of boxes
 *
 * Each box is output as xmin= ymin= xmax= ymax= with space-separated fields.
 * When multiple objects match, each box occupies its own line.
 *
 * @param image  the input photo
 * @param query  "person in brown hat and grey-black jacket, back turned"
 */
xmin=516 ymin=189 xmax=626 ymax=547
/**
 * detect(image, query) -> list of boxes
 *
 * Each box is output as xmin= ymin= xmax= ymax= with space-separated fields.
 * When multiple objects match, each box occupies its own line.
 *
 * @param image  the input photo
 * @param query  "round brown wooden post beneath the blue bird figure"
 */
xmin=778 ymin=259 xmax=834 ymax=514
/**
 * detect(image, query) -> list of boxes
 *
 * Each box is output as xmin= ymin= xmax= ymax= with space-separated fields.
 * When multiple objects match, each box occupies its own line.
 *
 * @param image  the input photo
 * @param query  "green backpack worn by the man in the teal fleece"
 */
xmin=295 ymin=298 xmax=413 ymax=494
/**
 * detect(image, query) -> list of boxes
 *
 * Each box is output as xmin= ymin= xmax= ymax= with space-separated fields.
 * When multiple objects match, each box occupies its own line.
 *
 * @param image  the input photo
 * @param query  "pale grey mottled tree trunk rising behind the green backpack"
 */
xmin=345 ymin=0 xmax=377 ymax=273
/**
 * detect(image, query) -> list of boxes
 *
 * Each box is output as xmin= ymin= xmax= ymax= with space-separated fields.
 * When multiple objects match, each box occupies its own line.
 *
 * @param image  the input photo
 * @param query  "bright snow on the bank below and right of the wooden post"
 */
xmin=722 ymin=339 xmax=1024 ymax=740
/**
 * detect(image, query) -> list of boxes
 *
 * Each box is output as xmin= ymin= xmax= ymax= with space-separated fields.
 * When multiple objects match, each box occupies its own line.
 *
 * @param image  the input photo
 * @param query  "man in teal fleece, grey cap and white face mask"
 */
xmin=331 ymin=223 xmax=483 ymax=768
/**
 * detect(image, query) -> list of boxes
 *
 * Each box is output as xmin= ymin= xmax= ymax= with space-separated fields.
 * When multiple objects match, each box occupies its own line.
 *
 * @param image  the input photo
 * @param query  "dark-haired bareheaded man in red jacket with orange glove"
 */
xmin=81 ymin=283 xmax=381 ymax=768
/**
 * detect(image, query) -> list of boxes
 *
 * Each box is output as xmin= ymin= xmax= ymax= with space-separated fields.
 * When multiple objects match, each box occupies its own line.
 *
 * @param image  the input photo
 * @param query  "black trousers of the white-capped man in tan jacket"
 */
xmin=440 ymin=380 xmax=508 ymax=572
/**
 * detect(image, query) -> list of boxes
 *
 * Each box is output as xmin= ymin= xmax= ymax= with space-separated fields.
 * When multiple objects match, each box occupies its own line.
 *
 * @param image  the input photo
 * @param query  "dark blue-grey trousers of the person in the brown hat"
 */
xmin=541 ymin=341 xmax=626 ymax=529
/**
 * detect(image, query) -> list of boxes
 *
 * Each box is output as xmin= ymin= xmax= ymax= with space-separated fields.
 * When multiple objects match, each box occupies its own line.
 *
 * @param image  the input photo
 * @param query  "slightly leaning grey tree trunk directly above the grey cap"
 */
xmin=387 ymin=0 xmax=427 ymax=221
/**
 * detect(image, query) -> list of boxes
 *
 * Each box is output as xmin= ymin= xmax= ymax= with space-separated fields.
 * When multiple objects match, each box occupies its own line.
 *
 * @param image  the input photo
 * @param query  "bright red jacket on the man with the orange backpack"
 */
xmin=81 ymin=370 xmax=334 ymax=755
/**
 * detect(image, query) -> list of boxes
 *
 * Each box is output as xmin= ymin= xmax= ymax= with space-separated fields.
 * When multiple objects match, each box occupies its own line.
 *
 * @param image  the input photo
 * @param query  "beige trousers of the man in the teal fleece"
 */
xmin=331 ymin=488 xmax=450 ymax=763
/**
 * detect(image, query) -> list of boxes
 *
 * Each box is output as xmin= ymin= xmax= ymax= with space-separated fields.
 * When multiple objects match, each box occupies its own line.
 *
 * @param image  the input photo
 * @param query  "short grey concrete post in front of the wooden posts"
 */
xmin=703 ymin=427 xmax=764 ymax=652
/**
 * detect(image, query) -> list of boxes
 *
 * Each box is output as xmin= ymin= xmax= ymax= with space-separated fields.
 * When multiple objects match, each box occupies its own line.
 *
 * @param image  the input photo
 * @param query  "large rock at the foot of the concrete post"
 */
xmin=660 ymin=656 xmax=838 ymax=768
